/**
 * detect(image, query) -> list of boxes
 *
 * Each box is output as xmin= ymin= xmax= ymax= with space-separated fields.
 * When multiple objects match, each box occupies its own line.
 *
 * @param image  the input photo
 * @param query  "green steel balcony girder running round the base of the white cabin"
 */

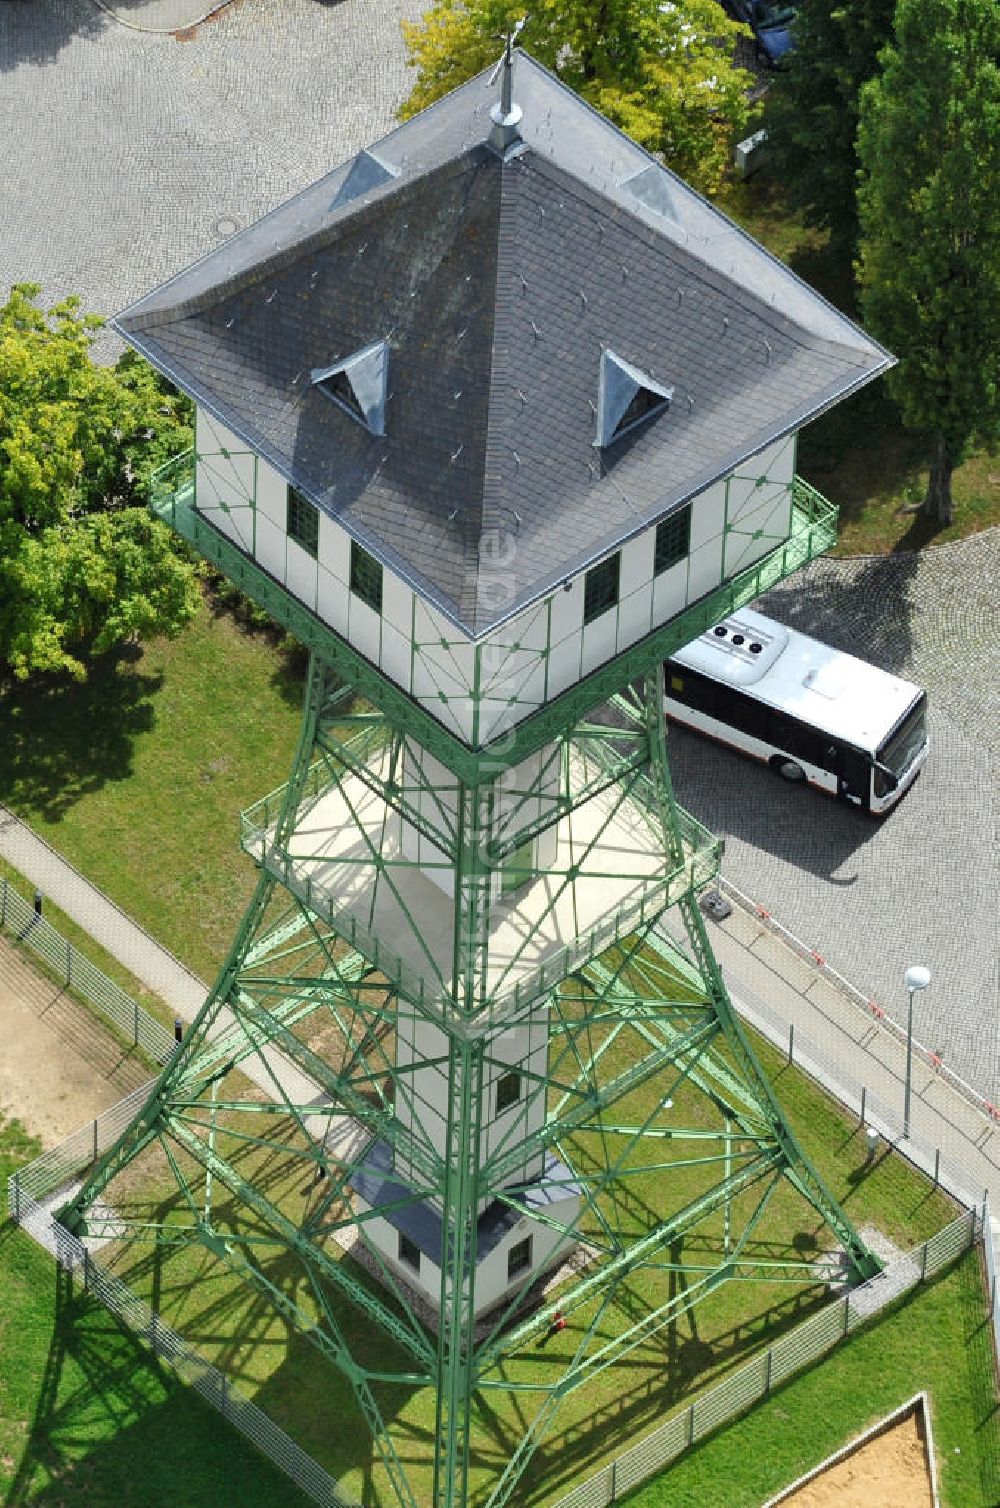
xmin=151 ymin=451 xmax=837 ymax=786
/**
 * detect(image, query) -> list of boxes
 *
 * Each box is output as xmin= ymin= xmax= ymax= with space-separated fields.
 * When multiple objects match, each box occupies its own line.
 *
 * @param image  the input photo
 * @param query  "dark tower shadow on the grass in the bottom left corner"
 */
xmin=5 ymin=1268 xmax=306 ymax=1508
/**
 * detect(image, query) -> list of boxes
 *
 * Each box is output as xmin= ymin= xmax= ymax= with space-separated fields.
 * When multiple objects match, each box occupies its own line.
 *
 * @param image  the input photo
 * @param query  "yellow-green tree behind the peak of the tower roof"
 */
xmin=401 ymin=0 xmax=751 ymax=193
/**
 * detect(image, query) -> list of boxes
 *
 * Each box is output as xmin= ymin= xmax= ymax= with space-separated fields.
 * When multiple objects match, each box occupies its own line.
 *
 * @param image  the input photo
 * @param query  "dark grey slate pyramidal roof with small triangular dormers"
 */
xmin=113 ymin=53 xmax=891 ymax=636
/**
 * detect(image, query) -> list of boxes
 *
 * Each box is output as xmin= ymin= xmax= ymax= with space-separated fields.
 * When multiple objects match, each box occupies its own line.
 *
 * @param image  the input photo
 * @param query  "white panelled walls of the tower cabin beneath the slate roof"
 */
xmin=196 ymin=410 xmax=795 ymax=745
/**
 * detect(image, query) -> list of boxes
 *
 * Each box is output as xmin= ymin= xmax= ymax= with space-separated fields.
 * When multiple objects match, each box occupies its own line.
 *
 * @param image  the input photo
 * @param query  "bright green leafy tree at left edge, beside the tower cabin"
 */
xmin=0 ymin=284 xmax=198 ymax=679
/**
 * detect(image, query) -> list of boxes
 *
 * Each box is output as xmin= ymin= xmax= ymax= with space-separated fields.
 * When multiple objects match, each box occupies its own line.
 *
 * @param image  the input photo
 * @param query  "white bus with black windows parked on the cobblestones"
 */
xmin=665 ymin=608 xmax=928 ymax=813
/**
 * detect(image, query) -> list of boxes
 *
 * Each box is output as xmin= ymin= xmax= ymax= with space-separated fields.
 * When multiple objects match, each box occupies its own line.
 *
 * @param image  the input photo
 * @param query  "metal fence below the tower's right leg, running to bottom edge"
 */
xmin=555 ymin=1209 xmax=989 ymax=1508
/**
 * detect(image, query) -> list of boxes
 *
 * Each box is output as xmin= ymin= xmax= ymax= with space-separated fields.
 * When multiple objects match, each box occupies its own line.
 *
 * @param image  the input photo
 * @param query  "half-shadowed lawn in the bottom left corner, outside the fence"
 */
xmin=0 ymin=1123 xmax=309 ymax=1508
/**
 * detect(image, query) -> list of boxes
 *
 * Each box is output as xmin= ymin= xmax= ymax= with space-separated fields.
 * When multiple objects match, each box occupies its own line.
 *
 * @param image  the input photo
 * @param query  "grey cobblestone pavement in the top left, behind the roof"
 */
xmin=0 ymin=0 xmax=422 ymax=350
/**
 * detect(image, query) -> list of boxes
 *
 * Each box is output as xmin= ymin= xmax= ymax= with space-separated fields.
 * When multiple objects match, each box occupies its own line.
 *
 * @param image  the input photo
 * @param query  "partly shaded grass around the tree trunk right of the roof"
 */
xmin=721 ymin=173 xmax=1000 ymax=555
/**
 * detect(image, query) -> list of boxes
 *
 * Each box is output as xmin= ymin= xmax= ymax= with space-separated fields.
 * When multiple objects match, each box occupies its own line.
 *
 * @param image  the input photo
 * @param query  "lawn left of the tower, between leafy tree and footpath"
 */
xmin=0 ymin=606 xmax=302 ymax=980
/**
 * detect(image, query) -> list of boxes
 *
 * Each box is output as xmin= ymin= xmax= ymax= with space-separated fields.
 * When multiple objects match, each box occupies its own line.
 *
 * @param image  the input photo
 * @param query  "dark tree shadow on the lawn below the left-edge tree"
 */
xmin=0 ymin=647 xmax=163 ymax=822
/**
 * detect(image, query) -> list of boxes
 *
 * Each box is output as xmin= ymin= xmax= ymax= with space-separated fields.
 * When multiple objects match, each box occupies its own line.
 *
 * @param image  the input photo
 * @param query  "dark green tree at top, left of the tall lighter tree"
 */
xmin=765 ymin=0 xmax=896 ymax=262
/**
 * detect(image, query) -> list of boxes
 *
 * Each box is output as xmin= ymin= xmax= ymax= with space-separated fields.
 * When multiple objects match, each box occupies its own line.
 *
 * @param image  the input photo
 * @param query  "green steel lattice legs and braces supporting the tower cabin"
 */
xmin=68 ymin=582 xmax=873 ymax=1508
